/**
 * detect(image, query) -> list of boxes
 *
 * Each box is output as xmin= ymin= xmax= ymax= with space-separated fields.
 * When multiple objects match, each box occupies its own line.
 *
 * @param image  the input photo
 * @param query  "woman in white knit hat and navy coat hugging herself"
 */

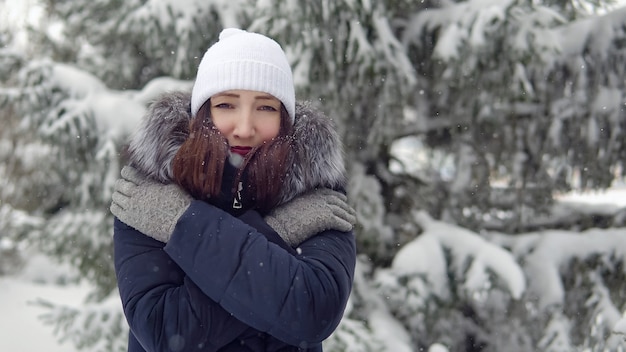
xmin=111 ymin=29 xmax=356 ymax=351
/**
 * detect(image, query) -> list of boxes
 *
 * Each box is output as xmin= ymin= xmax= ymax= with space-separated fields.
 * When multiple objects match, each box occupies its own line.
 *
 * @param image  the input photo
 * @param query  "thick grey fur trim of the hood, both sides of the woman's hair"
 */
xmin=129 ymin=92 xmax=346 ymax=204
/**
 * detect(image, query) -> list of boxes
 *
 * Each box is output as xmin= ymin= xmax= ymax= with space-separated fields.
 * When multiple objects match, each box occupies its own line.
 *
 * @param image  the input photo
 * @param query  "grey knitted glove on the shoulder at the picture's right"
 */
xmin=264 ymin=188 xmax=356 ymax=247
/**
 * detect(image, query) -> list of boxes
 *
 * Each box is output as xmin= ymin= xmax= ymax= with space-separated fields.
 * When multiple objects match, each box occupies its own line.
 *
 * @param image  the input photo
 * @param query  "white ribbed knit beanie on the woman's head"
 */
xmin=191 ymin=28 xmax=296 ymax=122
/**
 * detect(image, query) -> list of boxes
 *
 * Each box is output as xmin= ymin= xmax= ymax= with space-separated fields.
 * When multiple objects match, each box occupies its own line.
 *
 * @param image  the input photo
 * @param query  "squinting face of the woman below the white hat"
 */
xmin=210 ymin=90 xmax=281 ymax=155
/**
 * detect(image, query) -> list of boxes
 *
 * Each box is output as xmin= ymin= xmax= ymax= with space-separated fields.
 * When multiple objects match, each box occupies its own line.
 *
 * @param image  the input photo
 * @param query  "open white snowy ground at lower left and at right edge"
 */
xmin=0 ymin=185 xmax=626 ymax=352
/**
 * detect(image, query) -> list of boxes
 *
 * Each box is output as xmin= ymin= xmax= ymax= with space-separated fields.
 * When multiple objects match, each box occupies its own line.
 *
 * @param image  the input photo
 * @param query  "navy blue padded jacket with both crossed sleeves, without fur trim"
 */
xmin=114 ymin=201 xmax=356 ymax=352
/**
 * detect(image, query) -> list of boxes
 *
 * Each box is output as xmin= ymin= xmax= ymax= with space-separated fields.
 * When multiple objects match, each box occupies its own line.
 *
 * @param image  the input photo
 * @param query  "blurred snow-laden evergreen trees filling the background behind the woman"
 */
xmin=0 ymin=0 xmax=626 ymax=352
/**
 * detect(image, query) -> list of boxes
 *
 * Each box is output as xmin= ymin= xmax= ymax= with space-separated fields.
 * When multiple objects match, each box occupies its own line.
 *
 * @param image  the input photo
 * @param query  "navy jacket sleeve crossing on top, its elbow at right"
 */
xmin=164 ymin=201 xmax=356 ymax=347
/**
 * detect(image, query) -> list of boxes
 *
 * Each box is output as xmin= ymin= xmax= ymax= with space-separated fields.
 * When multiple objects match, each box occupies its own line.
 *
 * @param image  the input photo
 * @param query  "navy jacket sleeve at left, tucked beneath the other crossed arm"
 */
xmin=114 ymin=219 xmax=248 ymax=351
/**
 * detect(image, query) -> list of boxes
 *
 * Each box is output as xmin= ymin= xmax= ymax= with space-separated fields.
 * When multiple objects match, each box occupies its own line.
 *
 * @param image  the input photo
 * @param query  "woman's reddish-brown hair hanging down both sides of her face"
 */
xmin=172 ymin=100 xmax=293 ymax=214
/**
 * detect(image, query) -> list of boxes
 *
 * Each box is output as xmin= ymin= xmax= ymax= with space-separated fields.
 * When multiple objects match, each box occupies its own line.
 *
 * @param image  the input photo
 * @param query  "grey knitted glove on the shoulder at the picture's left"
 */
xmin=111 ymin=166 xmax=192 ymax=243
